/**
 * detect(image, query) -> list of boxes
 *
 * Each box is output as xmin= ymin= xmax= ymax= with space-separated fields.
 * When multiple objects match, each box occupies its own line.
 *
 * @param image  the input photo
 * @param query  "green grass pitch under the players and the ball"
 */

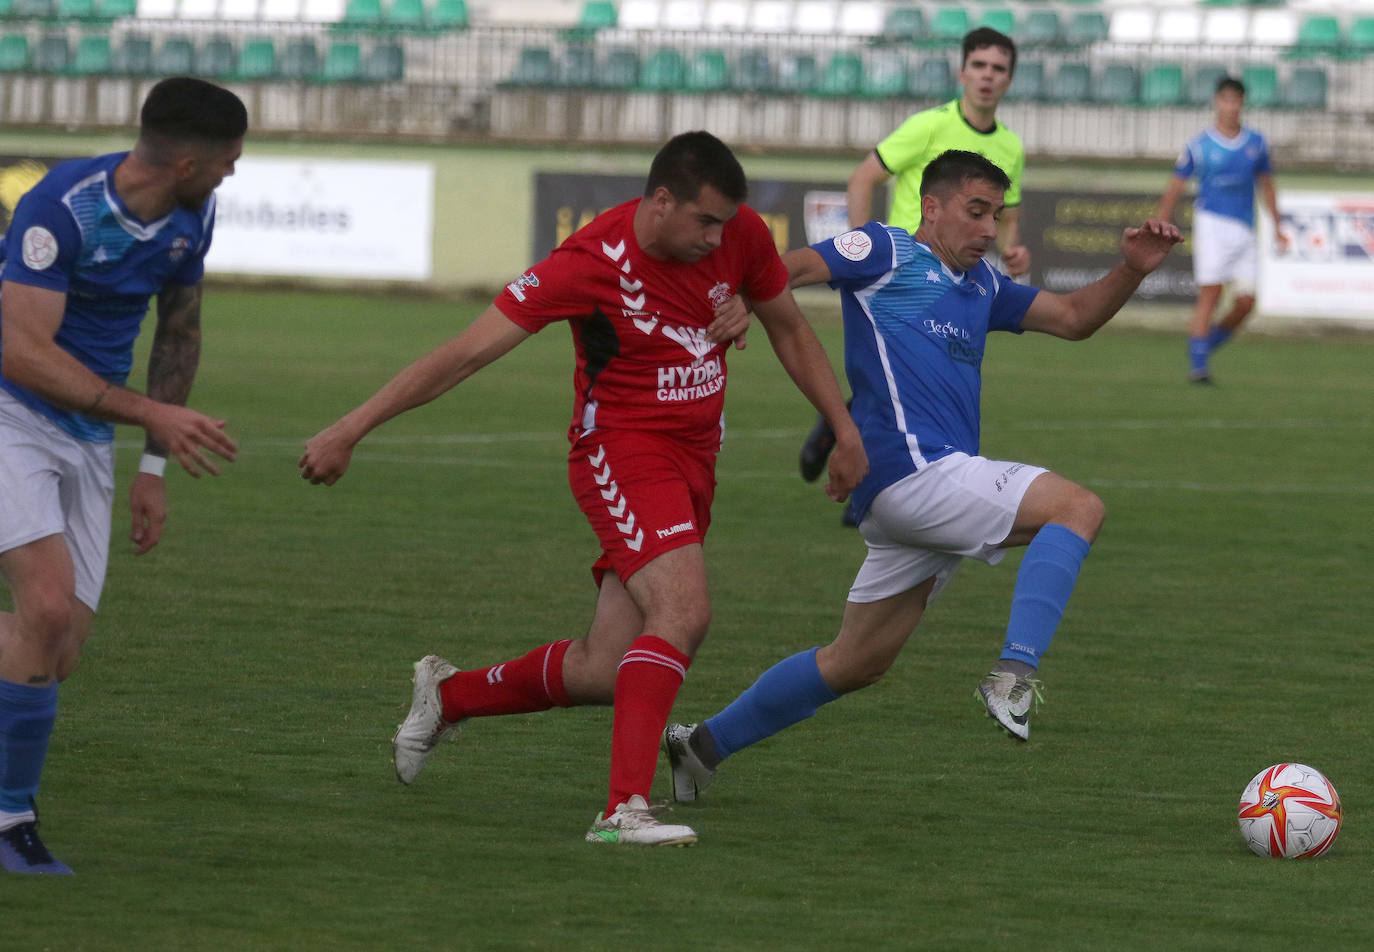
xmin=0 ymin=288 xmax=1374 ymax=952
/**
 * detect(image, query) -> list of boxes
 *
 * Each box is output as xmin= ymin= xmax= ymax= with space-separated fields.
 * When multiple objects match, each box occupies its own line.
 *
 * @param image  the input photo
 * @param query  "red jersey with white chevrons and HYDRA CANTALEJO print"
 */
xmin=496 ymin=199 xmax=787 ymax=449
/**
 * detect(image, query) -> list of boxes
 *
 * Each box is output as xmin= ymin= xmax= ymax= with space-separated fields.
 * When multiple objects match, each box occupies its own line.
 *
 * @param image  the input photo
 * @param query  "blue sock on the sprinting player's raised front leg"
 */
xmin=1002 ymin=523 xmax=1090 ymax=668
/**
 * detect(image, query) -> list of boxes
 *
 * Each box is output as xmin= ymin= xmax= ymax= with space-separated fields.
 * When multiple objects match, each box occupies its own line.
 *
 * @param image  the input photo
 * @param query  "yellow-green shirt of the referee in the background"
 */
xmin=875 ymin=99 xmax=1026 ymax=231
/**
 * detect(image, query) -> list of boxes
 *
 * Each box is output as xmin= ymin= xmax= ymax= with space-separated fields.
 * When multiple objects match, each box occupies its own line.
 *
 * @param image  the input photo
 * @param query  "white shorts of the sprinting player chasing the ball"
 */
xmin=849 ymin=453 xmax=1047 ymax=602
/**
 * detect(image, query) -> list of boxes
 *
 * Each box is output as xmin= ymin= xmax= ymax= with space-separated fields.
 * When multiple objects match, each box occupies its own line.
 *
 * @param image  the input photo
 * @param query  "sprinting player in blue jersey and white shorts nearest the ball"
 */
xmin=664 ymin=151 xmax=1180 ymax=801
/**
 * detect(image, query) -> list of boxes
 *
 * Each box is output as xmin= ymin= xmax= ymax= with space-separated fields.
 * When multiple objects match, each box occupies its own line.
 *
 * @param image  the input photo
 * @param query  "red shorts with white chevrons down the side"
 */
xmin=567 ymin=430 xmax=716 ymax=585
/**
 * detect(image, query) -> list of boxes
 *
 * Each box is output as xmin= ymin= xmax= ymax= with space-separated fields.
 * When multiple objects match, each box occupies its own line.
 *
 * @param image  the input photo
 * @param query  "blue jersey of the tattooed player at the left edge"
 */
xmin=0 ymin=152 xmax=214 ymax=442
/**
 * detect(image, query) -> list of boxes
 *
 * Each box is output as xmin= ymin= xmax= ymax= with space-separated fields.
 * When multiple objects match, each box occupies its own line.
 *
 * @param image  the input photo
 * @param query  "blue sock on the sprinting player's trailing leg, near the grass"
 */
xmin=706 ymin=648 xmax=840 ymax=760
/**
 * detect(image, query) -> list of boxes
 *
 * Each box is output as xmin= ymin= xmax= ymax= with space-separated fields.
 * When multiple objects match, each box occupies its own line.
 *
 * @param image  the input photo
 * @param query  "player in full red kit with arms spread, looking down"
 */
xmin=300 ymin=132 xmax=868 ymax=846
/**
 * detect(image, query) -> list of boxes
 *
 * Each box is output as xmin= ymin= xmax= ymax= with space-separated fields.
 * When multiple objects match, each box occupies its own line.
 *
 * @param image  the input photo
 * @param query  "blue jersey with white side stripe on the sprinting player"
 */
xmin=812 ymin=221 xmax=1040 ymax=519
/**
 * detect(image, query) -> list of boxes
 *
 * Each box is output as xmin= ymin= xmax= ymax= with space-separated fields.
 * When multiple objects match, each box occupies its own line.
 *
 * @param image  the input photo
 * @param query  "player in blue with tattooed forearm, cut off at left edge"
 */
xmin=0 ymin=77 xmax=247 ymax=872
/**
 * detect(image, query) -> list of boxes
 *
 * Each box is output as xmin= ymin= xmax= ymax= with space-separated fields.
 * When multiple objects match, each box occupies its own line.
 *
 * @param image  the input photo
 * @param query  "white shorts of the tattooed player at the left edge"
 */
xmin=0 ymin=390 xmax=114 ymax=611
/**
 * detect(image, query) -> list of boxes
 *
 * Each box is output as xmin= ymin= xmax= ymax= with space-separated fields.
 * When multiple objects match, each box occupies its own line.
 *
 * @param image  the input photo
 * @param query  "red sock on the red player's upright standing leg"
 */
xmin=606 ymin=635 xmax=691 ymax=816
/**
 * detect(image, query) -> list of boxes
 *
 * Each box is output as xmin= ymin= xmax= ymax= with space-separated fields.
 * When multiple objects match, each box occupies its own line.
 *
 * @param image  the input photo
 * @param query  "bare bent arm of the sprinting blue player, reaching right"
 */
xmin=1021 ymin=218 xmax=1183 ymax=341
